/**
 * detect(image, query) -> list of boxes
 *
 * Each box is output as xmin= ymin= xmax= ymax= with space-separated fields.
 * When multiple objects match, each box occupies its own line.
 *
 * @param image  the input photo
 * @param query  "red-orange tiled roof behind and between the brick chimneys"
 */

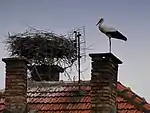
xmin=0 ymin=81 xmax=150 ymax=113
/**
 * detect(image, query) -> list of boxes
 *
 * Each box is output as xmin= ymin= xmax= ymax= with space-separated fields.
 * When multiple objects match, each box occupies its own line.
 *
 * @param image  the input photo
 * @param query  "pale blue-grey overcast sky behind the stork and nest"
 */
xmin=0 ymin=0 xmax=150 ymax=102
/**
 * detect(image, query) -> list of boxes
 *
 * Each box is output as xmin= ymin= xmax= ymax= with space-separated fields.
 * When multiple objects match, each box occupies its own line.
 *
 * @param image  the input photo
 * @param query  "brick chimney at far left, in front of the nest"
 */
xmin=2 ymin=58 xmax=28 ymax=113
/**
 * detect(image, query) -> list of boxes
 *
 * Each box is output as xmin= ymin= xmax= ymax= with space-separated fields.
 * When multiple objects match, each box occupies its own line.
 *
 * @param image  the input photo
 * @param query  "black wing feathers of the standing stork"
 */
xmin=106 ymin=31 xmax=127 ymax=41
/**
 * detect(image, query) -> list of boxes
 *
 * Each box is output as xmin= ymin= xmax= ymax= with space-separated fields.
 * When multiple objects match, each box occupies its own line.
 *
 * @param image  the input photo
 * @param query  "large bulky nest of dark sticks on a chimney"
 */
xmin=7 ymin=30 xmax=76 ymax=69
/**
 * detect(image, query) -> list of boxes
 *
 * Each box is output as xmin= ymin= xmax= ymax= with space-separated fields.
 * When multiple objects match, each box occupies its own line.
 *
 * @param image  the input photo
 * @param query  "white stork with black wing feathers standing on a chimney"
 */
xmin=96 ymin=18 xmax=127 ymax=53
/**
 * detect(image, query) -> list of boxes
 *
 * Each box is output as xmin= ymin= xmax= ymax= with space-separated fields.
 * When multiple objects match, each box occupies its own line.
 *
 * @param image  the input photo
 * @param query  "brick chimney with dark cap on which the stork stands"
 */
xmin=89 ymin=53 xmax=122 ymax=113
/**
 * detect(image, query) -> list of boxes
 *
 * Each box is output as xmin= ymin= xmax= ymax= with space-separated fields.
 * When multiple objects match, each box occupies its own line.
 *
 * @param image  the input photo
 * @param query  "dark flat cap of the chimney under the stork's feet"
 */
xmin=89 ymin=53 xmax=123 ymax=64
